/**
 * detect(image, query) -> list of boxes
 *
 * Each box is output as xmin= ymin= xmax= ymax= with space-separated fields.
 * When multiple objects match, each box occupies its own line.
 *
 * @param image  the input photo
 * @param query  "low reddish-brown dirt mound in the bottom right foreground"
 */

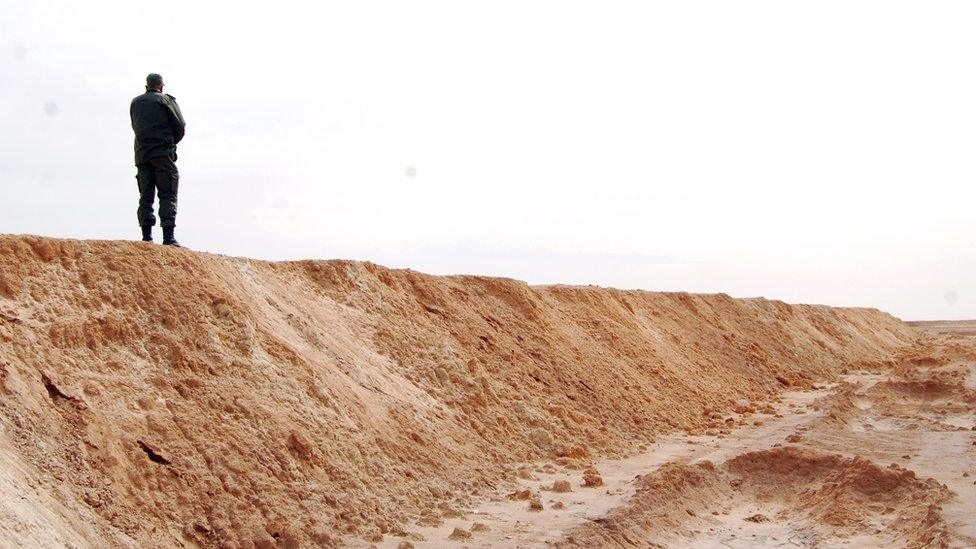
xmin=560 ymin=447 xmax=951 ymax=547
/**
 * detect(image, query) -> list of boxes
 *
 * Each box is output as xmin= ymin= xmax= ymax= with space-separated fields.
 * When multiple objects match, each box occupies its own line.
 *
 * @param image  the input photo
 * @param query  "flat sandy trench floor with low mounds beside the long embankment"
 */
xmin=380 ymin=366 xmax=976 ymax=548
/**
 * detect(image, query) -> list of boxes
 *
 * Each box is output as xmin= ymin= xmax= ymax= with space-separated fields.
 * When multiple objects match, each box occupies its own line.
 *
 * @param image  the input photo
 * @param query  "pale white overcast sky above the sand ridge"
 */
xmin=0 ymin=0 xmax=976 ymax=319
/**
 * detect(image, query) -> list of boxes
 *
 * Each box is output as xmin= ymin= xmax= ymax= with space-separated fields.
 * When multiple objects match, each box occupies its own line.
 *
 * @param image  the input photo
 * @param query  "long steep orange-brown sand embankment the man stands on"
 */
xmin=0 ymin=236 xmax=919 ymax=546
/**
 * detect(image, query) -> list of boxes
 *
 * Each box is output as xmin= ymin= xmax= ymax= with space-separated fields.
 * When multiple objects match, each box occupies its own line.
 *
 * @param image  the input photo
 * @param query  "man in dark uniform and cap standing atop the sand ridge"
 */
xmin=129 ymin=73 xmax=186 ymax=247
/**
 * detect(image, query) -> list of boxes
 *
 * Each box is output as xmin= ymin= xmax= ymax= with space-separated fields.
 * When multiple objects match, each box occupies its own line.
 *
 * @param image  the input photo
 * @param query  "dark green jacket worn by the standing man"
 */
xmin=129 ymin=90 xmax=186 ymax=166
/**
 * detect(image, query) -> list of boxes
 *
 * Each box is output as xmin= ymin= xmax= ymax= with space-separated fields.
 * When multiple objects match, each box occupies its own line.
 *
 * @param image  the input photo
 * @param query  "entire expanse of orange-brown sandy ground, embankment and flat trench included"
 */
xmin=0 ymin=236 xmax=976 ymax=548
